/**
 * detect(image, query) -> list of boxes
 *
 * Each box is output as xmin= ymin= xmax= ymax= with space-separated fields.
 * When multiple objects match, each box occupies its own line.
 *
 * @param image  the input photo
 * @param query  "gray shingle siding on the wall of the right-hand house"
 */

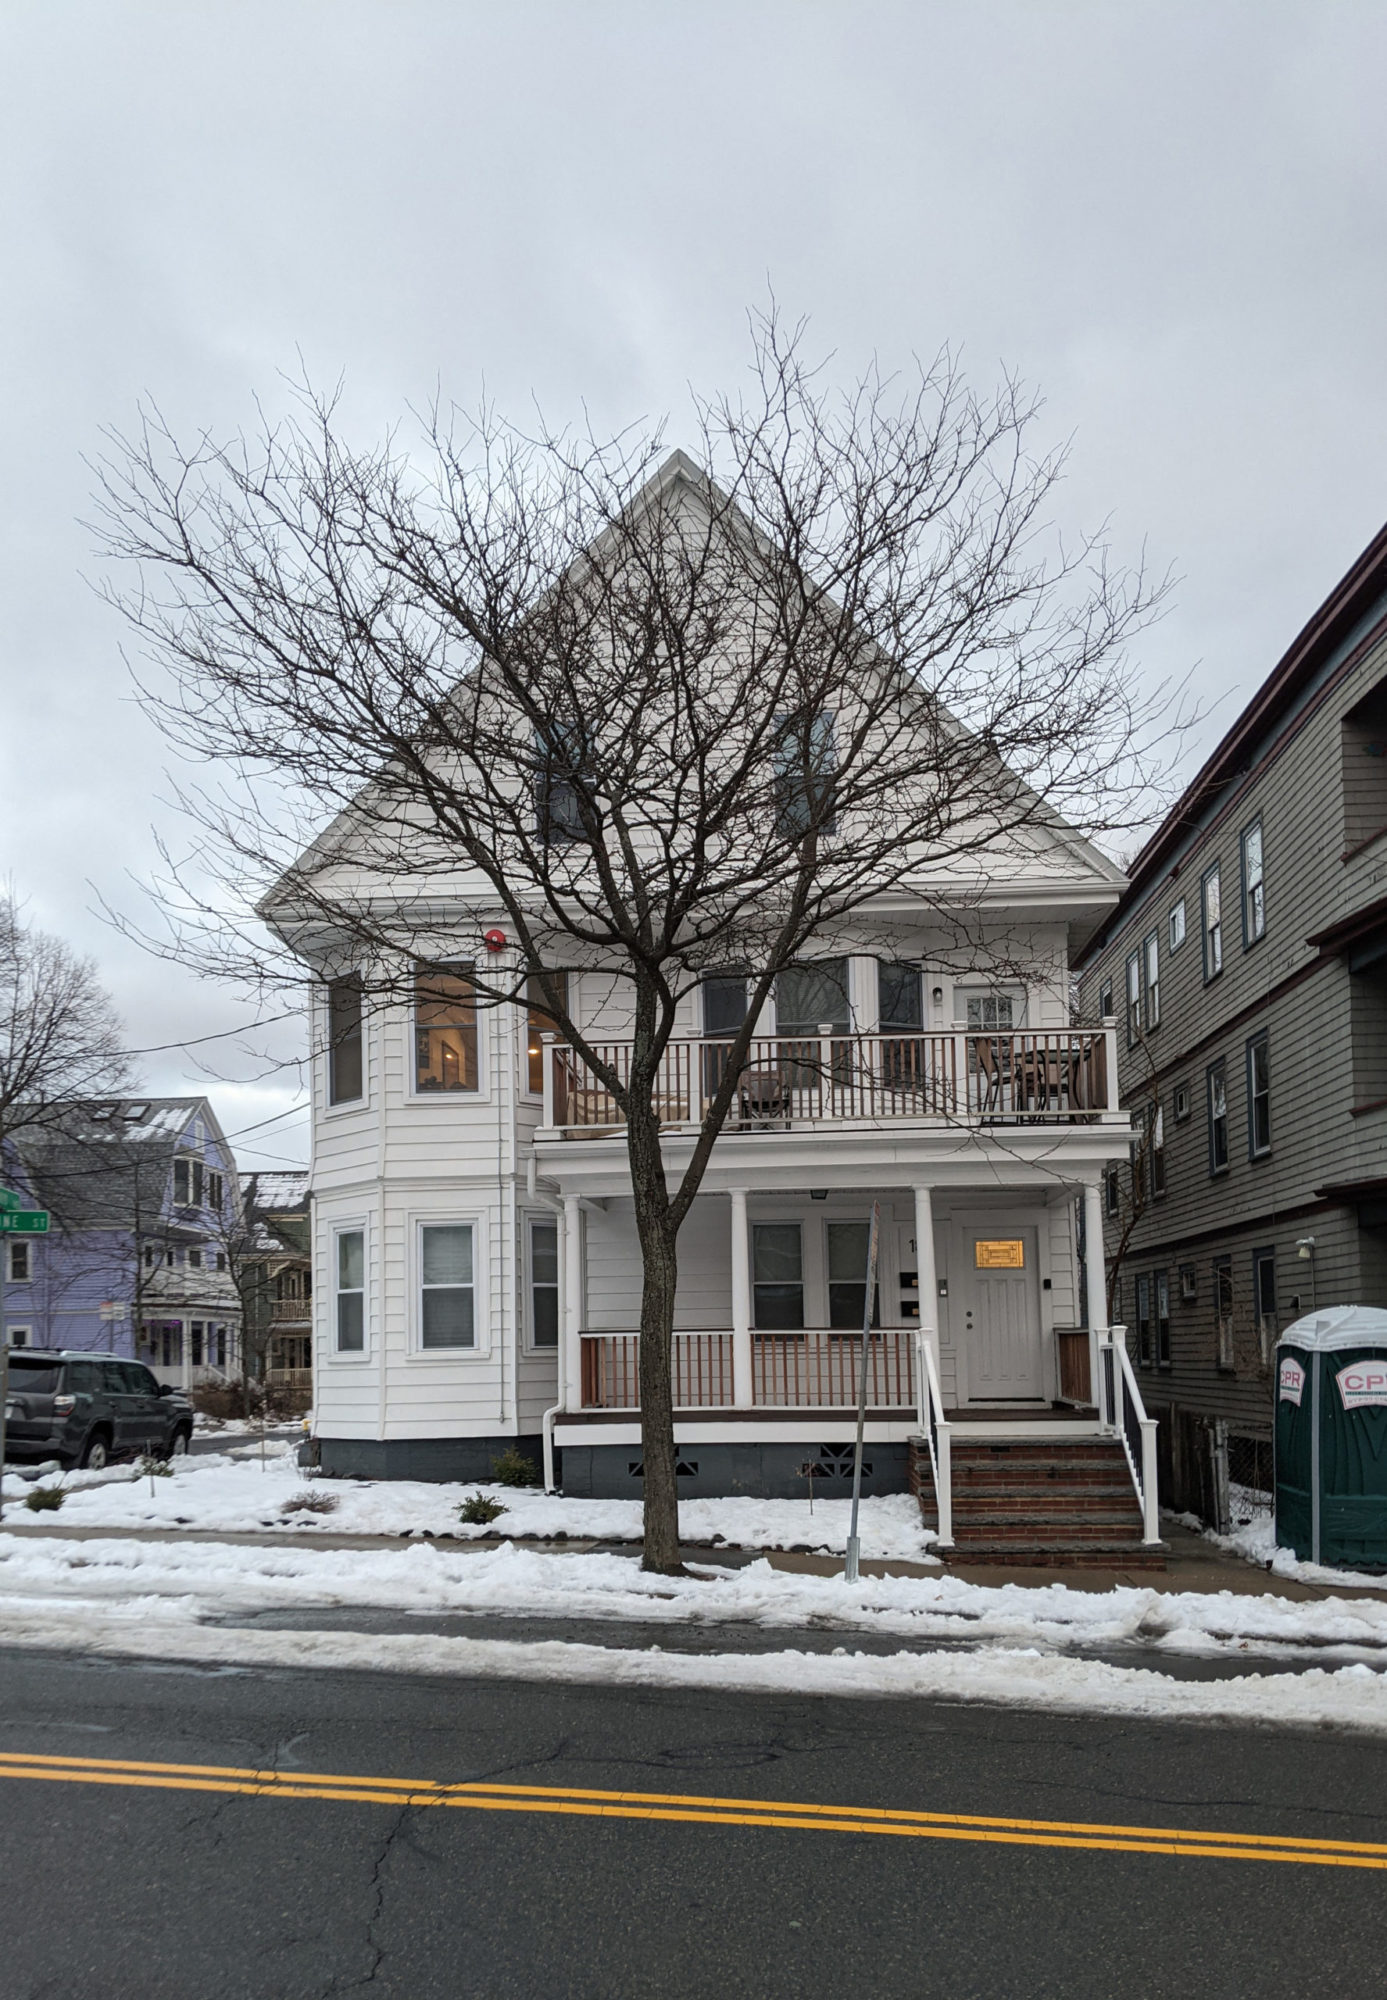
xmin=1079 ymin=556 xmax=1387 ymax=1464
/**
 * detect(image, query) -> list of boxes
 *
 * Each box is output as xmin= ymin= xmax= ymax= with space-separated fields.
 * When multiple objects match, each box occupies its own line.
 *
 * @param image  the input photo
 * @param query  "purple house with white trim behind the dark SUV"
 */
xmin=0 ymin=1098 xmax=240 ymax=1388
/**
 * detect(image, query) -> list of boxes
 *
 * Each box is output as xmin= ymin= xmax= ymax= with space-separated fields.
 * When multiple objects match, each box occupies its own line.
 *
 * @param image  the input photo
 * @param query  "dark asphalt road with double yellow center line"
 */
xmin=0 ymin=1652 xmax=1387 ymax=2000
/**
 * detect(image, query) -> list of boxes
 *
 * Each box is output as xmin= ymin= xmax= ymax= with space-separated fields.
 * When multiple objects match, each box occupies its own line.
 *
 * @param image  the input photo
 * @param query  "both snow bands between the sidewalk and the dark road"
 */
xmin=0 ymin=1536 xmax=1387 ymax=1734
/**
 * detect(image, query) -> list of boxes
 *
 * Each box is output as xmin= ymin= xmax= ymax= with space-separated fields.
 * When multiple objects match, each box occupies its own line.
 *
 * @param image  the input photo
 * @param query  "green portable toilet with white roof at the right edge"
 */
xmin=1277 ymin=1306 xmax=1387 ymax=1570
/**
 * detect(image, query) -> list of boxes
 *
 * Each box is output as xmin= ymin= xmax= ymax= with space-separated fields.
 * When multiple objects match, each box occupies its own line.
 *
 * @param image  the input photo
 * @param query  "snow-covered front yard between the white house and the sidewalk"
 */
xmin=4 ymin=1440 xmax=937 ymax=1562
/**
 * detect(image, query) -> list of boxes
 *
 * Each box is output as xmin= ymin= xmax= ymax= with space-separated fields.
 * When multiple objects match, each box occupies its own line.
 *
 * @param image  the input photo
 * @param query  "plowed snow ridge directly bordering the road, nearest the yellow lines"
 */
xmin=4 ymin=1576 xmax=1387 ymax=1734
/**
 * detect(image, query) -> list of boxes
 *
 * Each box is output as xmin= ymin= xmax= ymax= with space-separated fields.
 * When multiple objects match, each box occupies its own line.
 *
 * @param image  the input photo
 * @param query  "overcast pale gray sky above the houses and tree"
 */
xmin=0 ymin=0 xmax=1387 ymax=1164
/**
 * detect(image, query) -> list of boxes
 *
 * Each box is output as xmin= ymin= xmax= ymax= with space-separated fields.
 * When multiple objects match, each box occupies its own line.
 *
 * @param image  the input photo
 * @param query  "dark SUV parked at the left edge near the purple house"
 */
xmin=4 ymin=1348 xmax=192 ymax=1466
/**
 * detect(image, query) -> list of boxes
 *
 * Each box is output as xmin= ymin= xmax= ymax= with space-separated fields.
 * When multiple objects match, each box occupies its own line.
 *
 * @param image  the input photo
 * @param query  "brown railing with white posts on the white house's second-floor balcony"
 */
xmin=544 ymin=1028 xmax=1117 ymax=1138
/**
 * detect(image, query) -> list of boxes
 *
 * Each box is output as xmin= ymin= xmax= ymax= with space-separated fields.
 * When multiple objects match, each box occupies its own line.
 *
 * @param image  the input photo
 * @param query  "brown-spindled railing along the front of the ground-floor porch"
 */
xmin=580 ymin=1326 xmax=915 ymax=1410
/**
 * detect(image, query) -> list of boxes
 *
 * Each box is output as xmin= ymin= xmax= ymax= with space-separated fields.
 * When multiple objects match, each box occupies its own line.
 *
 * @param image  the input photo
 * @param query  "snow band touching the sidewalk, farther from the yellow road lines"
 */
xmin=0 ymin=1534 xmax=1387 ymax=1666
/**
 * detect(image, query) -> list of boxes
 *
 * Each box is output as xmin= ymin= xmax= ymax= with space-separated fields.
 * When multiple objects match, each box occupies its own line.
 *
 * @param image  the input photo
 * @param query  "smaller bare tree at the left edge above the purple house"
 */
xmin=0 ymin=896 xmax=132 ymax=1178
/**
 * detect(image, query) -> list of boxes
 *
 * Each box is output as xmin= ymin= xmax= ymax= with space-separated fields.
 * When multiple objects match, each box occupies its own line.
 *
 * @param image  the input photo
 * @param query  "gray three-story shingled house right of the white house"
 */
xmin=1075 ymin=528 xmax=1387 ymax=1518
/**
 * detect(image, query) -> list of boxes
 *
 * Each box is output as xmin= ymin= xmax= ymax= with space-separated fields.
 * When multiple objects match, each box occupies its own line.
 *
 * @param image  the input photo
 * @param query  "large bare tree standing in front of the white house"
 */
xmin=98 ymin=318 xmax=1167 ymax=1570
